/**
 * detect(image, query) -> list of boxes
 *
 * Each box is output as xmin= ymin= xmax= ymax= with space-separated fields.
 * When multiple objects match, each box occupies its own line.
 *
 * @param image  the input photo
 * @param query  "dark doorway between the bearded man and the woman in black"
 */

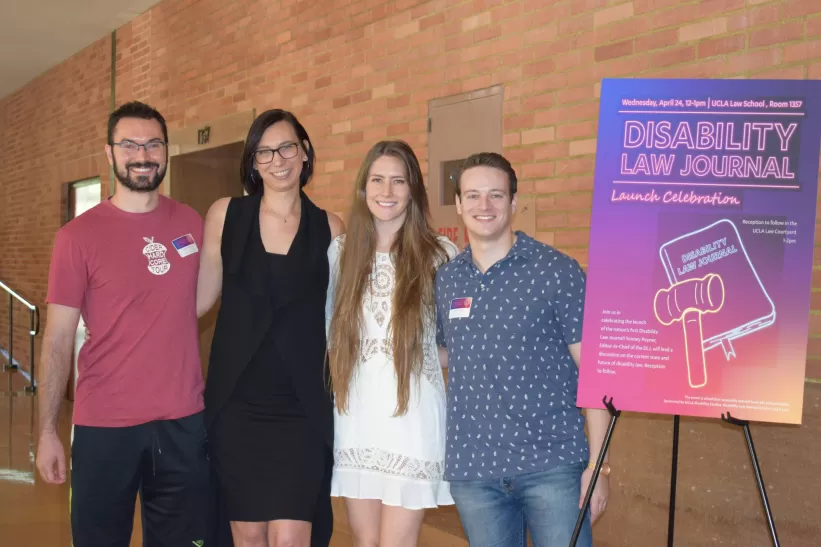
xmin=166 ymin=141 xmax=245 ymax=376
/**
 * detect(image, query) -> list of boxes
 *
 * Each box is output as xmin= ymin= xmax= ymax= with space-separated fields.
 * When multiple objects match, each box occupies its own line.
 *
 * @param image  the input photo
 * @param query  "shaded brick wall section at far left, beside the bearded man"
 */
xmin=0 ymin=38 xmax=111 ymax=378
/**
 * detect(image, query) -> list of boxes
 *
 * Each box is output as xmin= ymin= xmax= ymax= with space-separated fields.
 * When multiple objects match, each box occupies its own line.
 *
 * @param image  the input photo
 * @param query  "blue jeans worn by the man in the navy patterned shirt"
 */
xmin=450 ymin=463 xmax=593 ymax=547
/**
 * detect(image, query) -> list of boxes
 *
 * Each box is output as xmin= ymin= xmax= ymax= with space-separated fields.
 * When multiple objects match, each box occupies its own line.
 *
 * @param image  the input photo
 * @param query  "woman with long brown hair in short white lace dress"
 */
xmin=326 ymin=141 xmax=458 ymax=547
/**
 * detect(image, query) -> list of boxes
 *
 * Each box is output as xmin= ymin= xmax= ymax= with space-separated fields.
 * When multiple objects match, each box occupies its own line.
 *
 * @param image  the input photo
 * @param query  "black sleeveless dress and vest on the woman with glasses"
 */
xmin=205 ymin=193 xmax=333 ymax=546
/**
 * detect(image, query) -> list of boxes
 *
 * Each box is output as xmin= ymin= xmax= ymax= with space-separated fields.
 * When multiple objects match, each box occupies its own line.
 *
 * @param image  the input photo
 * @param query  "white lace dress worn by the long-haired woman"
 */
xmin=326 ymin=235 xmax=458 ymax=509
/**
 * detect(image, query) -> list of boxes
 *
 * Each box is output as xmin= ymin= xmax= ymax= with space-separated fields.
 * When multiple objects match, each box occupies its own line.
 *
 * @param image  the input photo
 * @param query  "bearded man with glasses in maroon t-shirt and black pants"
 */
xmin=37 ymin=102 xmax=210 ymax=547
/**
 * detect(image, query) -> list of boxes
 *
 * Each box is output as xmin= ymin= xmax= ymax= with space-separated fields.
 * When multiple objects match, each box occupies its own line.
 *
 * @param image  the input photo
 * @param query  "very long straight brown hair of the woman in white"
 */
xmin=328 ymin=141 xmax=448 ymax=415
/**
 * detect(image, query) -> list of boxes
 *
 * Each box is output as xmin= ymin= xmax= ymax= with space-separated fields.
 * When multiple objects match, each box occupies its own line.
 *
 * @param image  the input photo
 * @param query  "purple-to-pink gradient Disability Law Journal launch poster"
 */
xmin=577 ymin=79 xmax=821 ymax=424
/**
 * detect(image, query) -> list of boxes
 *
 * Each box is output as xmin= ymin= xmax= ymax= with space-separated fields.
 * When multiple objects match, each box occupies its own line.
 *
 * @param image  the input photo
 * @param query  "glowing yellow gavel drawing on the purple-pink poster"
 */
xmin=654 ymin=274 xmax=724 ymax=387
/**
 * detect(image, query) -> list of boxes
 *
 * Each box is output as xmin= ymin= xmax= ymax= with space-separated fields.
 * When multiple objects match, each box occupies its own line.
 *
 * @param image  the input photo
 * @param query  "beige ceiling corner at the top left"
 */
xmin=0 ymin=0 xmax=159 ymax=98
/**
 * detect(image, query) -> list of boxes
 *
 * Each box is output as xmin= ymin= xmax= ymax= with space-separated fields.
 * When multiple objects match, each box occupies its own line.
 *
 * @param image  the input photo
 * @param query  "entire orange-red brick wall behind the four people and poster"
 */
xmin=0 ymin=0 xmax=821 ymax=545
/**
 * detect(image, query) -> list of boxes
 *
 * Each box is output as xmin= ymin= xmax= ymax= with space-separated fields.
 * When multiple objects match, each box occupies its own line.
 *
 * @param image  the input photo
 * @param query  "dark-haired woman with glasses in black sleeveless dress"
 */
xmin=197 ymin=110 xmax=344 ymax=547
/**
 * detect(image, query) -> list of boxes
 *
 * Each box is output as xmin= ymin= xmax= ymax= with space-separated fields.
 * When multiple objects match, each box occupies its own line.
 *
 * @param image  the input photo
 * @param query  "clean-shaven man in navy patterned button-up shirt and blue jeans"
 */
xmin=436 ymin=153 xmax=609 ymax=547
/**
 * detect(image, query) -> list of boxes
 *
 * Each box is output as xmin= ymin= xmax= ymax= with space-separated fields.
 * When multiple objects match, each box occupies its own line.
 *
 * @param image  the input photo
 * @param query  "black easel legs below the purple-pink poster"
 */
xmin=570 ymin=402 xmax=781 ymax=547
